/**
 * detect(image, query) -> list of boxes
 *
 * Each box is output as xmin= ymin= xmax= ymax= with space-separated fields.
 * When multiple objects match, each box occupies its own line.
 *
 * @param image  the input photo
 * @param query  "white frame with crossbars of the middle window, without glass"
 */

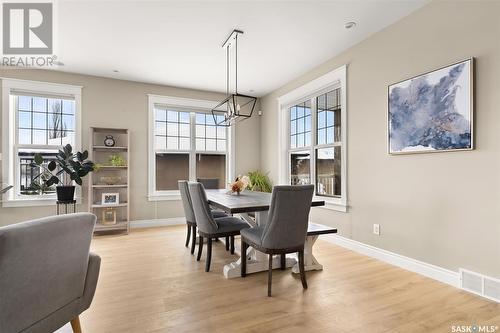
xmin=147 ymin=94 xmax=235 ymax=201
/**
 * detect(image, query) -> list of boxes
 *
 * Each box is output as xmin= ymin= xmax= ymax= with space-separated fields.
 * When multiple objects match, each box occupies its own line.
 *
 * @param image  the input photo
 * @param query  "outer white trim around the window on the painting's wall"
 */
xmin=278 ymin=65 xmax=347 ymax=212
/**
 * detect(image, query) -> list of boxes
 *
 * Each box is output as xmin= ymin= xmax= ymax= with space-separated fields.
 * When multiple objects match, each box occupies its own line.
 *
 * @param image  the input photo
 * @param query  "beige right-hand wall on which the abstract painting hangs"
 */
xmin=261 ymin=1 xmax=500 ymax=278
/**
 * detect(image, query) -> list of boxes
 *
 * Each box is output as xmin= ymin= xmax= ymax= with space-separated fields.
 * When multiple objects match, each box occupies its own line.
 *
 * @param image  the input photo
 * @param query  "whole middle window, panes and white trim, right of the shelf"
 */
xmin=149 ymin=95 xmax=230 ymax=200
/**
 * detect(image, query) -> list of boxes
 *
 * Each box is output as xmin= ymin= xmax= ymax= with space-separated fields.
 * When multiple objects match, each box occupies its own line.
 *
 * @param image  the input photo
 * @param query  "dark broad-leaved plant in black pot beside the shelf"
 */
xmin=31 ymin=144 xmax=95 ymax=201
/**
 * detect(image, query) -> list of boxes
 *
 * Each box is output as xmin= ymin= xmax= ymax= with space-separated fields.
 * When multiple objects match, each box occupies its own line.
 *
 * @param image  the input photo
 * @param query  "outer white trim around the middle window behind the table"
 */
xmin=148 ymin=94 xmax=235 ymax=201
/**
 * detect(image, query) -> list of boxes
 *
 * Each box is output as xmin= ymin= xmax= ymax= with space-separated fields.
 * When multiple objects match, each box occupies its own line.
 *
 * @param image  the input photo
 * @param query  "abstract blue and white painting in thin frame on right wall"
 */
xmin=389 ymin=59 xmax=473 ymax=154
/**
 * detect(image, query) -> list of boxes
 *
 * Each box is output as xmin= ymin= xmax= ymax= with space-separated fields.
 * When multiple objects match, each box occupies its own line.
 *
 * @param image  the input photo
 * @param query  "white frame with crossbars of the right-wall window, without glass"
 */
xmin=278 ymin=65 xmax=347 ymax=212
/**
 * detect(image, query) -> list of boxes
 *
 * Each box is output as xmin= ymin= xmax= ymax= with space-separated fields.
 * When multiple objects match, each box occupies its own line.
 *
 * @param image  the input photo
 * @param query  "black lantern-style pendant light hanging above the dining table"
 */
xmin=212 ymin=29 xmax=257 ymax=126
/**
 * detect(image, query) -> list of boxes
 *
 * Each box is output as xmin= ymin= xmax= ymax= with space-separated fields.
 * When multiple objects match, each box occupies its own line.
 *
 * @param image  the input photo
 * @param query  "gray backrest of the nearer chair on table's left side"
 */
xmin=188 ymin=182 xmax=218 ymax=234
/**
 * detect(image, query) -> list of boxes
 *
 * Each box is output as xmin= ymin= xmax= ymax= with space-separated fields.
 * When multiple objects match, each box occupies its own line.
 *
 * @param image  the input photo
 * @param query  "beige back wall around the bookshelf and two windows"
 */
xmin=0 ymin=70 xmax=260 ymax=225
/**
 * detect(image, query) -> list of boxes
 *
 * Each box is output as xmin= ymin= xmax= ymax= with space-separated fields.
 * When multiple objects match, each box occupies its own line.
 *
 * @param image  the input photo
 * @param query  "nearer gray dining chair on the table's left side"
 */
xmin=188 ymin=182 xmax=249 ymax=272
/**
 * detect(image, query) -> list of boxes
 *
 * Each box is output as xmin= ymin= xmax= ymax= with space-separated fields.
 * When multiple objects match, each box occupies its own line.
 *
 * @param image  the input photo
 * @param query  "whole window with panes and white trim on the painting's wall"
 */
xmin=279 ymin=67 xmax=347 ymax=211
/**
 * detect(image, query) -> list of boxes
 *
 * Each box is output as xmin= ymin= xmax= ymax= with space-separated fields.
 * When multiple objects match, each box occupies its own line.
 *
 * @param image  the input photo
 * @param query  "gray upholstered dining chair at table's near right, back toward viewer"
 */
xmin=241 ymin=185 xmax=314 ymax=296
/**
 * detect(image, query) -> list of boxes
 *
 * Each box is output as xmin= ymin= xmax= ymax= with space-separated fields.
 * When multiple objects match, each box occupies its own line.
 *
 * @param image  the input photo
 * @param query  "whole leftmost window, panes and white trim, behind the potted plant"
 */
xmin=2 ymin=79 xmax=81 ymax=206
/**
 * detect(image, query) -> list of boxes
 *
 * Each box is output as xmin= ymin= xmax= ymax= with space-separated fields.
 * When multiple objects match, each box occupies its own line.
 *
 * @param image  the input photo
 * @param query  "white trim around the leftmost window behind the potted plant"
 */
xmin=0 ymin=77 xmax=82 ymax=207
